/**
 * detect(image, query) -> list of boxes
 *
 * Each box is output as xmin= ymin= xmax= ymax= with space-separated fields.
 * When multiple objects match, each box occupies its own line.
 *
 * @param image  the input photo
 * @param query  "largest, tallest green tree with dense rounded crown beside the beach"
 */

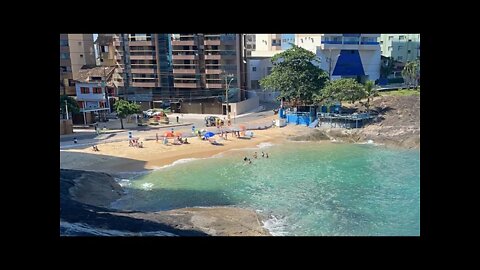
xmin=260 ymin=44 xmax=328 ymax=105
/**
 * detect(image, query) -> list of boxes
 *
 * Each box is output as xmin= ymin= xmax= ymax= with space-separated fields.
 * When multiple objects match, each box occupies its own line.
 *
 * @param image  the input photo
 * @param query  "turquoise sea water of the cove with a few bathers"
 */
xmin=114 ymin=142 xmax=420 ymax=236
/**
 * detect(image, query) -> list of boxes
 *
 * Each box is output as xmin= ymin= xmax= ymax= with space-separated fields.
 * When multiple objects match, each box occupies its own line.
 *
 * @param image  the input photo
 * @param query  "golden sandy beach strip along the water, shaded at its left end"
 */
xmin=60 ymin=126 xmax=311 ymax=174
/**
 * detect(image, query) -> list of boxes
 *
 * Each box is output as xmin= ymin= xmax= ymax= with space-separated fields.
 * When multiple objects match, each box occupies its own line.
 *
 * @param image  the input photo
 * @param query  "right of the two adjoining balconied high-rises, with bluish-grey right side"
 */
xmin=171 ymin=34 xmax=246 ymax=113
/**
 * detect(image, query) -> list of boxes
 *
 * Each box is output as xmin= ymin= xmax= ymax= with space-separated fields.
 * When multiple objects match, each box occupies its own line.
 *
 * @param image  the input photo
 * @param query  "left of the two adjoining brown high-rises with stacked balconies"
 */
xmin=112 ymin=34 xmax=173 ymax=109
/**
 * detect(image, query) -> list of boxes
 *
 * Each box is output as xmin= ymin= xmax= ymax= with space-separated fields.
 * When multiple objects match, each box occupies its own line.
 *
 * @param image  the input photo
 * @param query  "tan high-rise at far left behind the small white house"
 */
xmin=60 ymin=34 xmax=95 ymax=96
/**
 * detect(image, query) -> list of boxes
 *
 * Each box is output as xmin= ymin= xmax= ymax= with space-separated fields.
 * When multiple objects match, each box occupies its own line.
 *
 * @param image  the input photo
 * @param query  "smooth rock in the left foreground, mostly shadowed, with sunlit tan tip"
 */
xmin=60 ymin=169 xmax=270 ymax=236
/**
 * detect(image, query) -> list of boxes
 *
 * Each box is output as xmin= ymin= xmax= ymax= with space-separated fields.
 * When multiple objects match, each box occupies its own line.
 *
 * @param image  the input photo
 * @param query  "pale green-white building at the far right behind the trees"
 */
xmin=380 ymin=34 xmax=420 ymax=63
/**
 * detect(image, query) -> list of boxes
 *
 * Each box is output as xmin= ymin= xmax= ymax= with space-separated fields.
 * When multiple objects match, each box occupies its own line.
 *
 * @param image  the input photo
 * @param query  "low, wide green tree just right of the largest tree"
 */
xmin=314 ymin=79 xmax=365 ymax=104
